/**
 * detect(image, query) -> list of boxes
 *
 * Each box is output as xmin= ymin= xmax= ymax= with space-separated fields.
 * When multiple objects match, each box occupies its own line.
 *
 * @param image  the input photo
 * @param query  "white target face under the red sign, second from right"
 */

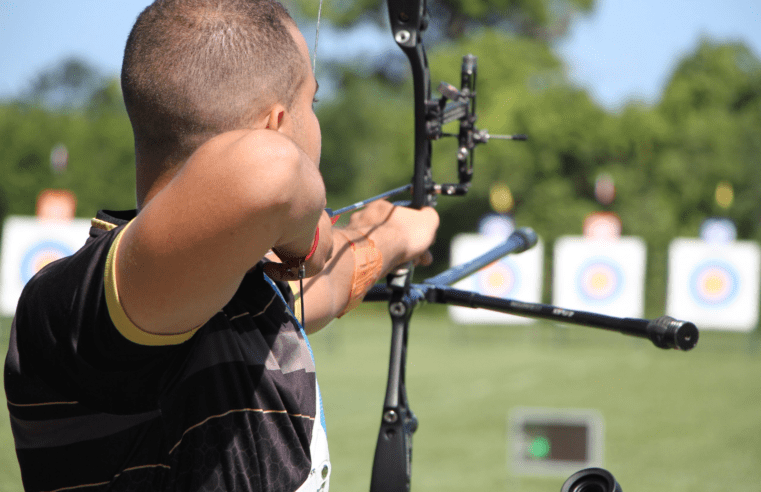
xmin=552 ymin=236 xmax=646 ymax=318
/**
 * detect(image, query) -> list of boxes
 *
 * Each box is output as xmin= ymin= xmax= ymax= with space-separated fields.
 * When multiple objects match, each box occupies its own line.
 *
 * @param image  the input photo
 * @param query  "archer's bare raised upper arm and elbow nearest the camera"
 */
xmin=114 ymin=131 xmax=325 ymax=334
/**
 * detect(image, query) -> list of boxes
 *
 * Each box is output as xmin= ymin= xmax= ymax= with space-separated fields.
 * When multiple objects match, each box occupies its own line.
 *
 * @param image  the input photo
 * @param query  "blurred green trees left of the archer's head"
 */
xmin=0 ymin=75 xmax=135 ymax=223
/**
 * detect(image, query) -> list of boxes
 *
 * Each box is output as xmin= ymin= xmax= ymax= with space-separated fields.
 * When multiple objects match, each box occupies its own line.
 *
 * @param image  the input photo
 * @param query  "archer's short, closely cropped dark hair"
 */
xmin=121 ymin=0 xmax=306 ymax=167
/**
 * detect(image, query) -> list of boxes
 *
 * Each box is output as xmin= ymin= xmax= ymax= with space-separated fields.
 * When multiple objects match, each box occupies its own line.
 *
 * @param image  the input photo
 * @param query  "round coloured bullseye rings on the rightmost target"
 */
xmin=690 ymin=260 xmax=740 ymax=307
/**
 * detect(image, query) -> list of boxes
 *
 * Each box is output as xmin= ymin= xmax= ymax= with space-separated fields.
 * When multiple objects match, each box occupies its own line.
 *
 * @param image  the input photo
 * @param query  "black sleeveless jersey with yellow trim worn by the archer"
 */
xmin=5 ymin=212 xmax=329 ymax=492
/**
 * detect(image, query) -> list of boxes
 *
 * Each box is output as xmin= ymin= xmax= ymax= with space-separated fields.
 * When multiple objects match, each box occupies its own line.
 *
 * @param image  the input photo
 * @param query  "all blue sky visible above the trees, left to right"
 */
xmin=0 ymin=0 xmax=761 ymax=109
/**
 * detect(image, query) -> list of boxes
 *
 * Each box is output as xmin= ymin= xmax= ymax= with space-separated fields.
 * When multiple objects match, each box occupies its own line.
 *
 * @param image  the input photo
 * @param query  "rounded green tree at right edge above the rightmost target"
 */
xmin=658 ymin=41 xmax=761 ymax=238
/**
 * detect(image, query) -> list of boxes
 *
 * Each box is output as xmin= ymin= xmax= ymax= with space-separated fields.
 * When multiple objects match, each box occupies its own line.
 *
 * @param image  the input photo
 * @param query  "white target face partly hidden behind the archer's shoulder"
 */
xmin=0 ymin=216 xmax=90 ymax=316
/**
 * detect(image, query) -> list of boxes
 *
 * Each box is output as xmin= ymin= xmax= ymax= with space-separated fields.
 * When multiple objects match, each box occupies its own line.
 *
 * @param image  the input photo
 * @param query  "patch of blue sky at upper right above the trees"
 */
xmin=557 ymin=0 xmax=761 ymax=107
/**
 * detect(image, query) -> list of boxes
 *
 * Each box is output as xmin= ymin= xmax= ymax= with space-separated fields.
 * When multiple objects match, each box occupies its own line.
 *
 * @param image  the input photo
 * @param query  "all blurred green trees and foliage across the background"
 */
xmin=0 ymin=0 xmax=761 ymax=315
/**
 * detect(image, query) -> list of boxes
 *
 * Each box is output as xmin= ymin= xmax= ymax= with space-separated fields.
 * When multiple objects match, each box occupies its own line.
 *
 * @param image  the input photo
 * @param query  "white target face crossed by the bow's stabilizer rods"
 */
xmin=449 ymin=234 xmax=544 ymax=324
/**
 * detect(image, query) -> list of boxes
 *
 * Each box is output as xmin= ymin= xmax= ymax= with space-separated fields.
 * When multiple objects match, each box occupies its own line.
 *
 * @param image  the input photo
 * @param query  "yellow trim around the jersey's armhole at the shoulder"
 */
xmin=104 ymin=222 xmax=200 ymax=346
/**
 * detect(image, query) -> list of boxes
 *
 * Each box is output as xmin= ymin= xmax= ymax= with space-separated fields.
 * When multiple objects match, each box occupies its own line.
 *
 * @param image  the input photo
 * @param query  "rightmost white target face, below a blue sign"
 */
xmin=666 ymin=238 xmax=761 ymax=331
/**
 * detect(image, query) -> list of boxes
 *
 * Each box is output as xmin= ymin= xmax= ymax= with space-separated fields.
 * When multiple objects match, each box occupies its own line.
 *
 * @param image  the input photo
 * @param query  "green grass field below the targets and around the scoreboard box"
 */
xmin=0 ymin=306 xmax=761 ymax=492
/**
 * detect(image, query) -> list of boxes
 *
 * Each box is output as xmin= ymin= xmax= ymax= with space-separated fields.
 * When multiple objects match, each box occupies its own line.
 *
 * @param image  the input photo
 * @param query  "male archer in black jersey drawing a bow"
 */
xmin=5 ymin=0 xmax=438 ymax=492
